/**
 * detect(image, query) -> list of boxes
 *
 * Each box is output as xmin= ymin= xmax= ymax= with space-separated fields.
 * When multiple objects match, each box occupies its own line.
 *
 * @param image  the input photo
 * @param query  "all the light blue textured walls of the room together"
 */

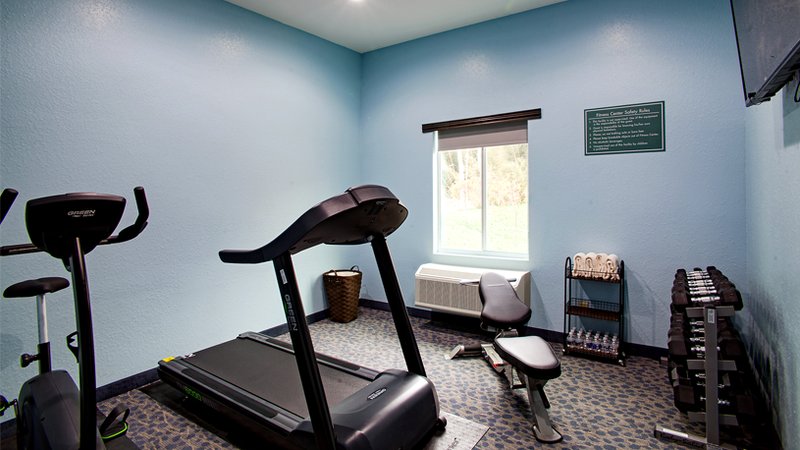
xmin=0 ymin=0 xmax=800 ymax=441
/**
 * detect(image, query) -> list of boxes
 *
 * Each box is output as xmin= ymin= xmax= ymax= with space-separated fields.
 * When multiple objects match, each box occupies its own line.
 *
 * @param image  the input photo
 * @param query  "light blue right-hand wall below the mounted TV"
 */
xmin=741 ymin=79 xmax=800 ymax=442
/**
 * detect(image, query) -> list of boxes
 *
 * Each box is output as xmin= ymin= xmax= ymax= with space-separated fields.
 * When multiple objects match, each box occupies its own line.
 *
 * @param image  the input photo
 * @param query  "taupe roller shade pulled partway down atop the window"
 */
xmin=438 ymin=120 xmax=528 ymax=151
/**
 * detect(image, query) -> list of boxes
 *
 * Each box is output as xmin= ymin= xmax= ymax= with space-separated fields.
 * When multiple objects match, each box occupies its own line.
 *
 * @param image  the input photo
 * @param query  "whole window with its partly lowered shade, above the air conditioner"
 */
xmin=423 ymin=110 xmax=540 ymax=259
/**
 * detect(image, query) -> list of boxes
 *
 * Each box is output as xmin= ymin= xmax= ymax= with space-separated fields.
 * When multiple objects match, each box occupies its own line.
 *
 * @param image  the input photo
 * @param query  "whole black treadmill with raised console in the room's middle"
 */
xmin=158 ymin=185 xmax=445 ymax=450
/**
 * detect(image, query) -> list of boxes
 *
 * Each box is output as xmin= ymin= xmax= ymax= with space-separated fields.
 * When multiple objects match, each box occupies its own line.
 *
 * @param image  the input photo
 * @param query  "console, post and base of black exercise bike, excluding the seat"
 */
xmin=0 ymin=187 xmax=149 ymax=450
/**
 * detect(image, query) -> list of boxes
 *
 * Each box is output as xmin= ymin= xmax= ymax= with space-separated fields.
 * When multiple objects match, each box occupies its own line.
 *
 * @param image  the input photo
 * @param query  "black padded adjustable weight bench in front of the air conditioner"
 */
xmin=447 ymin=272 xmax=562 ymax=443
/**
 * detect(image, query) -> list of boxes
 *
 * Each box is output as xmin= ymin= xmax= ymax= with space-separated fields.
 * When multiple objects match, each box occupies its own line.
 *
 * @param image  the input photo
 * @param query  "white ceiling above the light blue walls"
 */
xmin=226 ymin=0 xmax=564 ymax=53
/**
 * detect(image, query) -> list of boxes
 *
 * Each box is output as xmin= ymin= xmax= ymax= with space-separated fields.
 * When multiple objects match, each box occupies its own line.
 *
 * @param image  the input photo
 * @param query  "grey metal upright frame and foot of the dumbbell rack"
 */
xmin=653 ymin=268 xmax=741 ymax=448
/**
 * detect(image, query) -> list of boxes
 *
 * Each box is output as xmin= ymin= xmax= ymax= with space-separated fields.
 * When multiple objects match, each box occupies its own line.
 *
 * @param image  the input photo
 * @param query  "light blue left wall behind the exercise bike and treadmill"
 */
xmin=0 ymin=0 xmax=361 ymax=404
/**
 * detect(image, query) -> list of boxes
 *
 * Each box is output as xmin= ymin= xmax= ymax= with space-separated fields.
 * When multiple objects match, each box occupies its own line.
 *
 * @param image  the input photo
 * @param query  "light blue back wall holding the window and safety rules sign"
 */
xmin=361 ymin=0 xmax=745 ymax=348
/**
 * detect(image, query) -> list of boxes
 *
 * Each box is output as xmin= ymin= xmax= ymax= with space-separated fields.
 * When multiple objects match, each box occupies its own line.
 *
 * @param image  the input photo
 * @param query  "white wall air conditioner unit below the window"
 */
xmin=414 ymin=263 xmax=531 ymax=317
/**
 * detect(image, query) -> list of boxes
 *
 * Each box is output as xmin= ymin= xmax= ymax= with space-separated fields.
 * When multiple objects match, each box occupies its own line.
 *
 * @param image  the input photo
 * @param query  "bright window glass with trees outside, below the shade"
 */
xmin=439 ymin=144 xmax=528 ymax=256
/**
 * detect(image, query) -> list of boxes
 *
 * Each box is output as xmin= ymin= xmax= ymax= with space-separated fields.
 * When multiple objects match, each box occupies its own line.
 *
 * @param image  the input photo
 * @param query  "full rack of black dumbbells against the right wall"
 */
xmin=653 ymin=266 xmax=757 ymax=448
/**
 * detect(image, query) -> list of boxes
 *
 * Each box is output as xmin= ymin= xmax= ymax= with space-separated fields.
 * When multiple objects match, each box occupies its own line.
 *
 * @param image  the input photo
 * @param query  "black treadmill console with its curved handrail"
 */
xmin=219 ymin=184 xmax=408 ymax=264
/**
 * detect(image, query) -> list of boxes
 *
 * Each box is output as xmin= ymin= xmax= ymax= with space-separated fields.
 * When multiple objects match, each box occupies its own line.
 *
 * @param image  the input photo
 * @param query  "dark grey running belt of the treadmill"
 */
xmin=184 ymin=338 xmax=370 ymax=418
